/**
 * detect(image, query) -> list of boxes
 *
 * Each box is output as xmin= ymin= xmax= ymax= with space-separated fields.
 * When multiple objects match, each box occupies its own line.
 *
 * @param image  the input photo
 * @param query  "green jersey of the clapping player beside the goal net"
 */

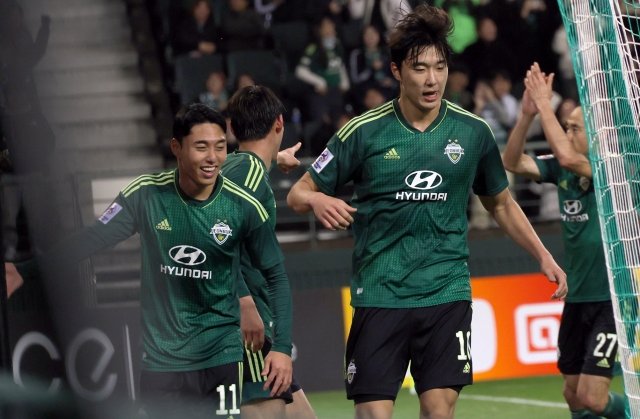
xmin=535 ymin=155 xmax=611 ymax=303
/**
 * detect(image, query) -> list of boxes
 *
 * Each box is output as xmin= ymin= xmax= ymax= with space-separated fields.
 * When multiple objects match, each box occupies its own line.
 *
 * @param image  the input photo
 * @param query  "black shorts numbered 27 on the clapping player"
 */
xmin=558 ymin=301 xmax=618 ymax=377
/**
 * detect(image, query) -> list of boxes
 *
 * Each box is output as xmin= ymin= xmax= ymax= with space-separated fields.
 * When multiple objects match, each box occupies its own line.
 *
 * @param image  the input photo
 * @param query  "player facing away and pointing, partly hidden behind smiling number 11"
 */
xmin=222 ymin=86 xmax=315 ymax=419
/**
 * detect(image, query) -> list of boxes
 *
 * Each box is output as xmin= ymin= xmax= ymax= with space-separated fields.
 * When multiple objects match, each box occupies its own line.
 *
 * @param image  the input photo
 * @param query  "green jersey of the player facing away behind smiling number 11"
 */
xmin=221 ymin=151 xmax=276 ymax=337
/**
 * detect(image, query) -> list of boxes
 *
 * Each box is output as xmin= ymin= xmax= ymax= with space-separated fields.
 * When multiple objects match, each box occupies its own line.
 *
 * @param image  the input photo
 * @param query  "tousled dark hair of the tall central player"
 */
xmin=388 ymin=4 xmax=453 ymax=69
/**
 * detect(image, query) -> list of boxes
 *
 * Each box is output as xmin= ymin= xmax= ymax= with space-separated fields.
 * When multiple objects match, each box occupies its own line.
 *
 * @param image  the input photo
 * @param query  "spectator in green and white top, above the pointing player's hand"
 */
xmin=295 ymin=17 xmax=349 ymax=124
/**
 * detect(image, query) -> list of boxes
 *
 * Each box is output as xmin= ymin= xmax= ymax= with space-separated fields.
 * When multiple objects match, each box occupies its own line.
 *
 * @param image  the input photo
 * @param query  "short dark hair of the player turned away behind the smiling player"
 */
xmin=227 ymin=86 xmax=285 ymax=142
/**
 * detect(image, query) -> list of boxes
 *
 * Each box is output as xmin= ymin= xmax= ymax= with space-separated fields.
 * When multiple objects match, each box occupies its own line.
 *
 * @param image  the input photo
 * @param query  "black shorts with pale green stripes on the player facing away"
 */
xmin=242 ymin=336 xmax=302 ymax=404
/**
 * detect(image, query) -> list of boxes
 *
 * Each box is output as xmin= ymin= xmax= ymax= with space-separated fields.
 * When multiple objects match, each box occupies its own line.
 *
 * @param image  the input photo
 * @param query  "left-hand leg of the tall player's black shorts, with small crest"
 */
xmin=345 ymin=307 xmax=414 ymax=404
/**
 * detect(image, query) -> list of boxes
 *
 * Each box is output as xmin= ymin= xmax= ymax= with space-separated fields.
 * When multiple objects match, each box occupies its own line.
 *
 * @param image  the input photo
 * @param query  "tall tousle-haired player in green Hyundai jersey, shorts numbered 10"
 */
xmin=287 ymin=5 xmax=567 ymax=419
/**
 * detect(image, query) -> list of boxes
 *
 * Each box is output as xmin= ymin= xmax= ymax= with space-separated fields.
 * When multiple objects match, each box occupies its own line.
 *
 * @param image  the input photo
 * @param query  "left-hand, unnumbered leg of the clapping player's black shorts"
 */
xmin=558 ymin=303 xmax=591 ymax=376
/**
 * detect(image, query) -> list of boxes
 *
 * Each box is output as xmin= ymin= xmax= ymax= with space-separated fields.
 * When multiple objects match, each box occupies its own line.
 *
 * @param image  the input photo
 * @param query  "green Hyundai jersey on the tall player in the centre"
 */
xmin=309 ymin=99 xmax=508 ymax=308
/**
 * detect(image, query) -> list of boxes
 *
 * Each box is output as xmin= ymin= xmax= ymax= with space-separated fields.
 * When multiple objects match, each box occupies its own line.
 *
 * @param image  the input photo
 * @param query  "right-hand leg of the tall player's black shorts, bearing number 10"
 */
xmin=410 ymin=301 xmax=473 ymax=394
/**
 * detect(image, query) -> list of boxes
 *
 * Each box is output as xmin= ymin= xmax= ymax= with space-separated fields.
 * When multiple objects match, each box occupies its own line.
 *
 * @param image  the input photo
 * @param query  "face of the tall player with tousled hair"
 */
xmin=391 ymin=47 xmax=449 ymax=113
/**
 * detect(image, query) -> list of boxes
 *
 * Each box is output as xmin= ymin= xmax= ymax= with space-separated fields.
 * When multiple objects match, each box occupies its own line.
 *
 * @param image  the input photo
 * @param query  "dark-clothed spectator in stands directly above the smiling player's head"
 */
xmin=171 ymin=0 xmax=219 ymax=57
